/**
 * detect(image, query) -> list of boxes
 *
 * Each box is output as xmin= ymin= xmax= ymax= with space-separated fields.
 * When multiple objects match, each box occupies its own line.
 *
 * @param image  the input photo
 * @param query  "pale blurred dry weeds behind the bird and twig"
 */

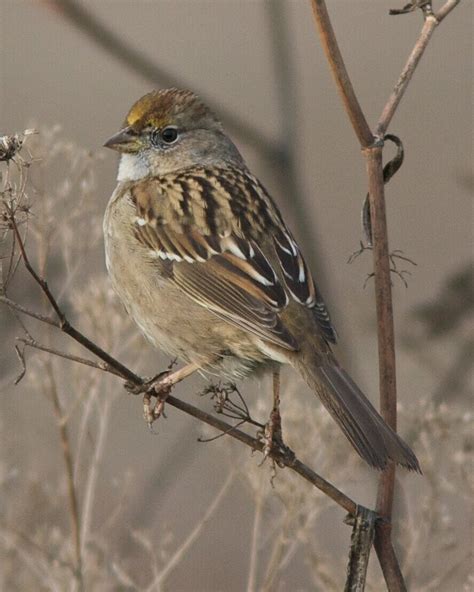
xmin=0 ymin=128 xmax=474 ymax=592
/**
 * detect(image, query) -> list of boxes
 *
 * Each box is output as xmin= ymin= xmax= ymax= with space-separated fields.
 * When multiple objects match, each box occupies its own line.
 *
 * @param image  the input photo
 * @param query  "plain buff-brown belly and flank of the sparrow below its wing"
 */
xmin=105 ymin=223 xmax=269 ymax=378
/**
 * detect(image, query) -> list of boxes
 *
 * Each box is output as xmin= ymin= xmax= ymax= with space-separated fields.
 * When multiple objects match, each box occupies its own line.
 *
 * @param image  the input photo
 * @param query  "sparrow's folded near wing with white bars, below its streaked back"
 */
xmin=143 ymin=226 xmax=296 ymax=349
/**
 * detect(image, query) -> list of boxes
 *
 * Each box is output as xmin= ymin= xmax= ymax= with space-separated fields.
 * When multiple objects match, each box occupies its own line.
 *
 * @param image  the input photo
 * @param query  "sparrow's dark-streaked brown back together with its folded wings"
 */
xmin=132 ymin=168 xmax=334 ymax=350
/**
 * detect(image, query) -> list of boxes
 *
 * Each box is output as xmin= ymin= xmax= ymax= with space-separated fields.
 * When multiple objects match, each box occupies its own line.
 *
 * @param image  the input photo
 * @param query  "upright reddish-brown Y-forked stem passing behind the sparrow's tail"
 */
xmin=311 ymin=0 xmax=460 ymax=592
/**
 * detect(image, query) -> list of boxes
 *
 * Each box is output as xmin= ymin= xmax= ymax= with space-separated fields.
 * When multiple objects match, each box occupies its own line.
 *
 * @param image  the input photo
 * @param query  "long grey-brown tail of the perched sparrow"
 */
xmin=293 ymin=356 xmax=421 ymax=473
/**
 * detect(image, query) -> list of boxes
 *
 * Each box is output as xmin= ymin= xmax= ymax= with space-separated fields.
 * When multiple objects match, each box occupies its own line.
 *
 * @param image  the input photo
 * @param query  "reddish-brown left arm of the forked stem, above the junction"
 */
xmin=311 ymin=0 xmax=374 ymax=148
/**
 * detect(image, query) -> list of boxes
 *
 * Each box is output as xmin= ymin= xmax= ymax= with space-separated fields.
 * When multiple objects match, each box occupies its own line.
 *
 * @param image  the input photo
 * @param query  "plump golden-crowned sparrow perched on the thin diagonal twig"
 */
xmin=104 ymin=89 xmax=419 ymax=470
